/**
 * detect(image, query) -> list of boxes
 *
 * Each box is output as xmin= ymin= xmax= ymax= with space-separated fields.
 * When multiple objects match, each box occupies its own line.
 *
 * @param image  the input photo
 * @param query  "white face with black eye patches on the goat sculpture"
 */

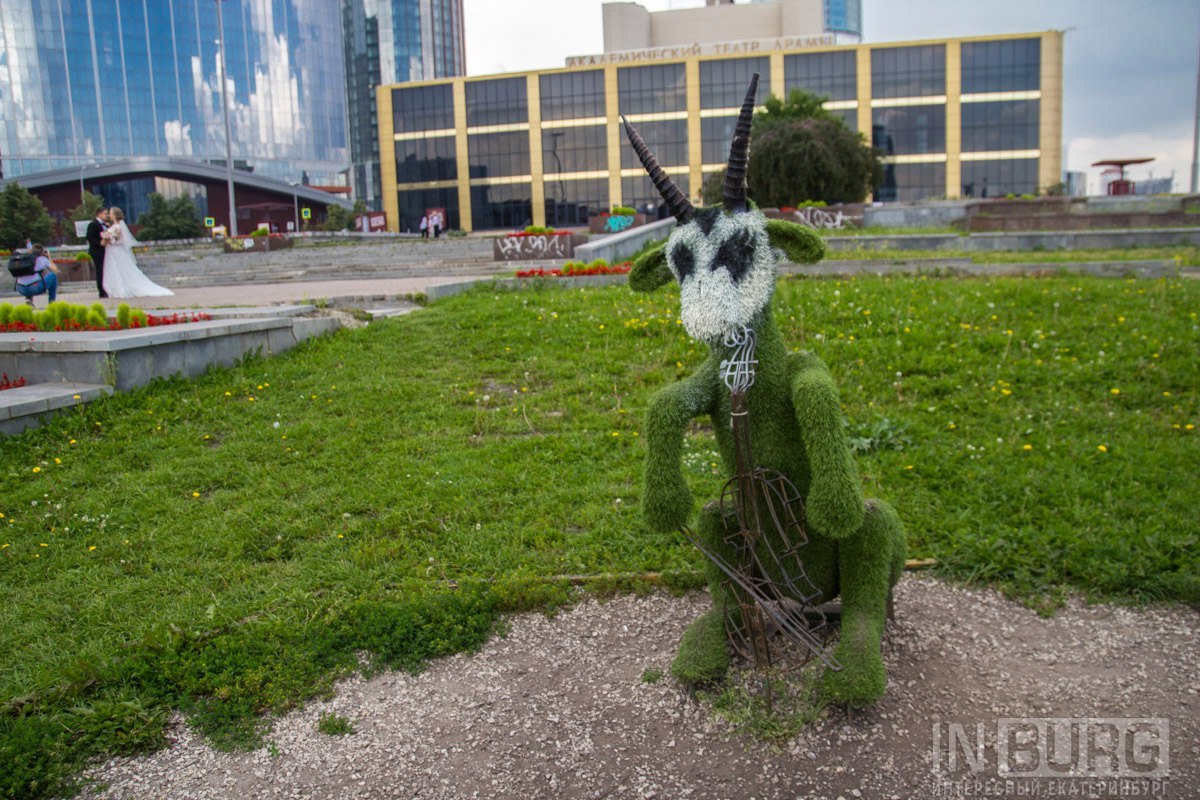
xmin=666 ymin=207 xmax=775 ymax=345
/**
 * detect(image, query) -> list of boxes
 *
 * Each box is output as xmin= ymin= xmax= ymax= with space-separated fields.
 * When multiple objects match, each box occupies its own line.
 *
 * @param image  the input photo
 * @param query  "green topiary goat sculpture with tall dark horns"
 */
xmin=624 ymin=74 xmax=905 ymax=705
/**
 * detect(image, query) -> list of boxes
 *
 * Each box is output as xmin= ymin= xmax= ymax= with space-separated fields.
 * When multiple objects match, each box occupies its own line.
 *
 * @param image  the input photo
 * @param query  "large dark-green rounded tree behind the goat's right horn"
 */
xmin=701 ymin=89 xmax=883 ymax=207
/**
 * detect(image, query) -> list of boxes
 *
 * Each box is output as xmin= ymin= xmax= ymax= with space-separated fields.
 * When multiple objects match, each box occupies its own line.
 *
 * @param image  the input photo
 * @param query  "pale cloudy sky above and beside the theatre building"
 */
xmin=464 ymin=0 xmax=1200 ymax=192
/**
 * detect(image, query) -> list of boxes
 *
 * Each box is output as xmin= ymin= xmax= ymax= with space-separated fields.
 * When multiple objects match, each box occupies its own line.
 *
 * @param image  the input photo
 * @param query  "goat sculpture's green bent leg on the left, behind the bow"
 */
xmin=671 ymin=503 xmax=737 ymax=686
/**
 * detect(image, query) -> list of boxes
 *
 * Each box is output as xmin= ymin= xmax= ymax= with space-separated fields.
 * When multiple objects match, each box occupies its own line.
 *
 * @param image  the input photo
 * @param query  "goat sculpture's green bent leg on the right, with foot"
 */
xmin=824 ymin=500 xmax=906 ymax=705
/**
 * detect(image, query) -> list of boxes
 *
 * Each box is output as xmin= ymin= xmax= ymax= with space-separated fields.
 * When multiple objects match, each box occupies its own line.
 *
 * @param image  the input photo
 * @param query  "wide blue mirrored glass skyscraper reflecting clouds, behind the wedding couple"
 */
xmin=0 ymin=0 xmax=349 ymax=185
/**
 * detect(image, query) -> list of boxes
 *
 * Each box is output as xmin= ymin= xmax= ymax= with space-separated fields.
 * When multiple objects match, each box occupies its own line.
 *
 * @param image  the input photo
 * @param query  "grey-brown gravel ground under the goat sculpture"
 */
xmin=92 ymin=575 xmax=1200 ymax=800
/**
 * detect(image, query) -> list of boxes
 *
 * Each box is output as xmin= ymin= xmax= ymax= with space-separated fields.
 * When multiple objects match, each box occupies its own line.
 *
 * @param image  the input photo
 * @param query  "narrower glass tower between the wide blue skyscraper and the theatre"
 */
xmin=341 ymin=0 xmax=467 ymax=209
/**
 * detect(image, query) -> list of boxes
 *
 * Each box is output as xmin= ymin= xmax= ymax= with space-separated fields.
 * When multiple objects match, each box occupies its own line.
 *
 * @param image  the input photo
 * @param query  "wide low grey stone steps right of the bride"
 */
xmin=138 ymin=237 xmax=549 ymax=288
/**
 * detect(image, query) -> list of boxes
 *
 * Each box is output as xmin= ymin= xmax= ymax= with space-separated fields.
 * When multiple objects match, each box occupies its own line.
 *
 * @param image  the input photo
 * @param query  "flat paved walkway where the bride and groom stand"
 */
xmin=46 ymin=275 xmax=490 ymax=308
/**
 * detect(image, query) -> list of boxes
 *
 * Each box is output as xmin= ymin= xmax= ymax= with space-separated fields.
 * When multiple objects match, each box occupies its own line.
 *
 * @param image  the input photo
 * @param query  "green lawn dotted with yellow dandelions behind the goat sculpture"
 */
xmin=0 ymin=277 xmax=1200 ymax=798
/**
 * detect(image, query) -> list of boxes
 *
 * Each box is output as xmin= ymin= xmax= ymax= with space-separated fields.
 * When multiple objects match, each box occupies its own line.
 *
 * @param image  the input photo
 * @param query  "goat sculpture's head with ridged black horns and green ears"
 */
xmin=622 ymin=73 xmax=824 ymax=345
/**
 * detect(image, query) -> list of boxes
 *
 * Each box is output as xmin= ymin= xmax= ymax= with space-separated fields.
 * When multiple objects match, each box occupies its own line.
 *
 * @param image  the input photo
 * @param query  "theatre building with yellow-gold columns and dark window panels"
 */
xmin=376 ymin=31 xmax=1062 ymax=230
